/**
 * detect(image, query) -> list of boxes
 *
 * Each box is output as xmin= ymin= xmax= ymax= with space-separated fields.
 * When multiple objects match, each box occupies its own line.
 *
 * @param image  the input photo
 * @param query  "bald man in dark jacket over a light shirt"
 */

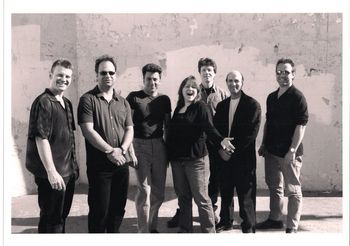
xmin=214 ymin=71 xmax=261 ymax=233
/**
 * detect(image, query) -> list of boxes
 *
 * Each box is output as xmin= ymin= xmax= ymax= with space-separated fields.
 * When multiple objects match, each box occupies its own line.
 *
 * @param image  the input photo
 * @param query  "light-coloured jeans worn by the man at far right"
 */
xmin=265 ymin=153 xmax=302 ymax=229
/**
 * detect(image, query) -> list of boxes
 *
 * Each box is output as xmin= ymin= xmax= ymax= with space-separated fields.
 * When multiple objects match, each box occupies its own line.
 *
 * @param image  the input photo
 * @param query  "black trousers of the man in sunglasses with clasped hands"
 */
xmin=87 ymin=165 xmax=129 ymax=233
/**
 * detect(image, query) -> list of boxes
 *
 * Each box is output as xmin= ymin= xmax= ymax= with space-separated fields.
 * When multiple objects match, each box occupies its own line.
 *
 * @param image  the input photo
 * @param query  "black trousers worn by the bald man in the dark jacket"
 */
xmin=220 ymin=163 xmax=256 ymax=232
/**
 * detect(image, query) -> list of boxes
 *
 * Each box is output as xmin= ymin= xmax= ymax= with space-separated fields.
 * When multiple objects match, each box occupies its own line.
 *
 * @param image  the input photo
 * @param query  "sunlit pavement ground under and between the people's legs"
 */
xmin=11 ymin=184 xmax=343 ymax=234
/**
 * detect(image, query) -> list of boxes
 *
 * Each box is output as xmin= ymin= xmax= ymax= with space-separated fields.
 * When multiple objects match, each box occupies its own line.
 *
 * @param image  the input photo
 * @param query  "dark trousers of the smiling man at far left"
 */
xmin=35 ymin=175 xmax=75 ymax=233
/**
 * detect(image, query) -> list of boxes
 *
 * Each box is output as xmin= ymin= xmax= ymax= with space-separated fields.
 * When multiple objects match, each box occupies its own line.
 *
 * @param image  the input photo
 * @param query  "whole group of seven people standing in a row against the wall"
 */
xmin=26 ymin=55 xmax=308 ymax=233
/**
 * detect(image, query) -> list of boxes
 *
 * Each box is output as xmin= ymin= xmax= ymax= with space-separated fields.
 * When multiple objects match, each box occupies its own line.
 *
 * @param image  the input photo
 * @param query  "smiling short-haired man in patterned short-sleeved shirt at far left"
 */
xmin=26 ymin=59 xmax=79 ymax=233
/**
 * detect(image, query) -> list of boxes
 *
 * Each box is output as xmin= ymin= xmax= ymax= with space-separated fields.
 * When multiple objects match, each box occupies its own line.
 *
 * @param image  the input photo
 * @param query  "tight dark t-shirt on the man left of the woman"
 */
xmin=126 ymin=90 xmax=171 ymax=138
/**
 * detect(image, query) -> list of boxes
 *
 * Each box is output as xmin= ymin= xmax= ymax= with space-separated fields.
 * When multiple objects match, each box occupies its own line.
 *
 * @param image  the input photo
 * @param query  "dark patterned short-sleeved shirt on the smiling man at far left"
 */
xmin=26 ymin=89 xmax=78 ymax=178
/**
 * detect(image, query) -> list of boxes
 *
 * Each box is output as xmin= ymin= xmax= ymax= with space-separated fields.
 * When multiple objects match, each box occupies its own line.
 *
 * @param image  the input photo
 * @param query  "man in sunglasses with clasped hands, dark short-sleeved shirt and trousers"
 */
xmin=78 ymin=56 xmax=136 ymax=233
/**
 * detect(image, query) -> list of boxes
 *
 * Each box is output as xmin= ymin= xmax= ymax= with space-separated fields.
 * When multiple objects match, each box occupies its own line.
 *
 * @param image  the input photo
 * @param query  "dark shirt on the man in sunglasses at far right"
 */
xmin=265 ymin=85 xmax=309 ymax=157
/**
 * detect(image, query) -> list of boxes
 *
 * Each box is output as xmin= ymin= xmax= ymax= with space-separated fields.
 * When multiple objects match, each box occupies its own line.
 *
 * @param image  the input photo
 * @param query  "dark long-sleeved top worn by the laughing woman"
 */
xmin=167 ymin=101 xmax=223 ymax=160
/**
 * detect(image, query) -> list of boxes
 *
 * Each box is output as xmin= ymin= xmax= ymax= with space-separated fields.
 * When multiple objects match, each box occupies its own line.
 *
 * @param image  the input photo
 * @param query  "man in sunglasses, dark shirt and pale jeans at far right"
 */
xmin=256 ymin=58 xmax=309 ymax=233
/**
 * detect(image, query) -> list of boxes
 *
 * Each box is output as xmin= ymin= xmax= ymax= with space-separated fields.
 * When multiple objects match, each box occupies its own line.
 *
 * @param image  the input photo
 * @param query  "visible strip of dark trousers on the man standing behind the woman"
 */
xmin=207 ymin=143 xmax=221 ymax=211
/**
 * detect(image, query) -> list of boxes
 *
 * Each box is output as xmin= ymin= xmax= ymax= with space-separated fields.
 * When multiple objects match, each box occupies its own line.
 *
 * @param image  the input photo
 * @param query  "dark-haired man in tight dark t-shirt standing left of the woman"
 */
xmin=126 ymin=64 xmax=171 ymax=233
